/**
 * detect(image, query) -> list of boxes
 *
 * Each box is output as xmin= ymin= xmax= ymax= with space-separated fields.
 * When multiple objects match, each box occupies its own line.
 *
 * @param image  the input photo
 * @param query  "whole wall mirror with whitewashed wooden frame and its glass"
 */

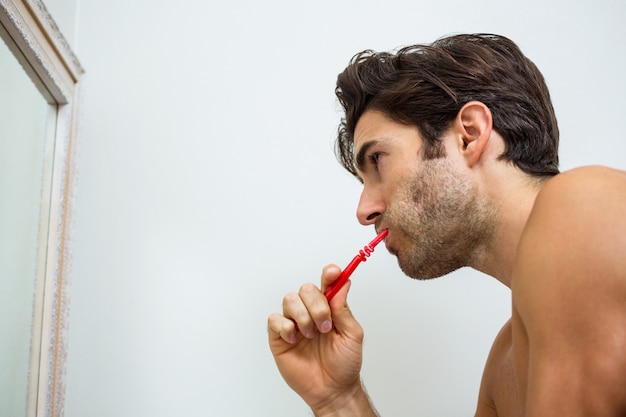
xmin=0 ymin=0 xmax=83 ymax=417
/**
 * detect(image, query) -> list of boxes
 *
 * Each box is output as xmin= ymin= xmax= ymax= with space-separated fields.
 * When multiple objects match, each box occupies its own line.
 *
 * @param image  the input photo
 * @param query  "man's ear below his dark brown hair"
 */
xmin=455 ymin=101 xmax=493 ymax=167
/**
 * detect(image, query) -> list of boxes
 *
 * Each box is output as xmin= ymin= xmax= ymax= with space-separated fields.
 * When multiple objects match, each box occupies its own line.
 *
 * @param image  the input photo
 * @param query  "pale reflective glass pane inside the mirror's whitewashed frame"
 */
xmin=0 ymin=35 xmax=54 ymax=416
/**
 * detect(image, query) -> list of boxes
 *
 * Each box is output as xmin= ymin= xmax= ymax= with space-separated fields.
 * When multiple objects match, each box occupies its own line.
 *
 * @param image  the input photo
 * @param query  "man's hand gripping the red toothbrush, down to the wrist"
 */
xmin=267 ymin=265 xmax=375 ymax=416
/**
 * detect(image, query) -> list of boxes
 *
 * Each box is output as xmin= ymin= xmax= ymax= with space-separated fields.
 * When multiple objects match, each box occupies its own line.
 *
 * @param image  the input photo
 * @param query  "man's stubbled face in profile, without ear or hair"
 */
xmin=354 ymin=110 xmax=495 ymax=279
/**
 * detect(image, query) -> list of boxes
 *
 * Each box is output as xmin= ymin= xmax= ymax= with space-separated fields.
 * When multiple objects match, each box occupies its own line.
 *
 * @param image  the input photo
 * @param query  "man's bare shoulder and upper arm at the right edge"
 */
xmin=512 ymin=168 xmax=626 ymax=417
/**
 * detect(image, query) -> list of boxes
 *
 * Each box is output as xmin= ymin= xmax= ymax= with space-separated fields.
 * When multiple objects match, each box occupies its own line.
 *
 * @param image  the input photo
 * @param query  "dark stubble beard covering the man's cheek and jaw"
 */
xmin=384 ymin=158 xmax=496 ymax=279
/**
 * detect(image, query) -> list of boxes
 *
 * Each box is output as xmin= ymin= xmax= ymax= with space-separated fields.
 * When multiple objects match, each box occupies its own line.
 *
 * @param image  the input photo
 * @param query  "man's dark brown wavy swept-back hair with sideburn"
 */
xmin=335 ymin=34 xmax=559 ymax=177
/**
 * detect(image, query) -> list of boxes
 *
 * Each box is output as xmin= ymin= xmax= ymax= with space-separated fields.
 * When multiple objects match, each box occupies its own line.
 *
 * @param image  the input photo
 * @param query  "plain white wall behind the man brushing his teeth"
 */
xmin=66 ymin=0 xmax=626 ymax=417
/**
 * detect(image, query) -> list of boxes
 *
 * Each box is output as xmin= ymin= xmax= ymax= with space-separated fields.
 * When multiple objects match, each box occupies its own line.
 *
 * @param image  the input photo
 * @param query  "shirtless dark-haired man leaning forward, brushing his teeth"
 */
xmin=268 ymin=35 xmax=626 ymax=417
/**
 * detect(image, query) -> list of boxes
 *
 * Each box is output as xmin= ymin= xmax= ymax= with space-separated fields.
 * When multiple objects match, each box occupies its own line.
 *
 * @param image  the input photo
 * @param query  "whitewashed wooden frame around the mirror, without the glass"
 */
xmin=0 ymin=0 xmax=84 ymax=417
